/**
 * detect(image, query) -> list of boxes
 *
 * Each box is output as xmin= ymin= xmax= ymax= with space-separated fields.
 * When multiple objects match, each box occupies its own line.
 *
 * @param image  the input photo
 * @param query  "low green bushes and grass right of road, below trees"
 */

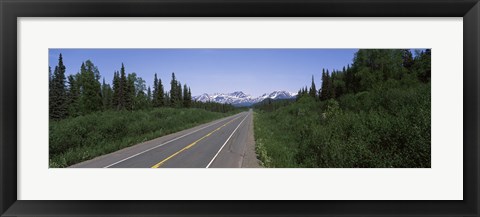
xmin=254 ymin=84 xmax=431 ymax=168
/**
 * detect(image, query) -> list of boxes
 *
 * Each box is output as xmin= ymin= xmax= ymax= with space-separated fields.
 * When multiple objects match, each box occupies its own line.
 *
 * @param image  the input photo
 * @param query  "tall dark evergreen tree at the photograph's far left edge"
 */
xmin=49 ymin=54 xmax=67 ymax=120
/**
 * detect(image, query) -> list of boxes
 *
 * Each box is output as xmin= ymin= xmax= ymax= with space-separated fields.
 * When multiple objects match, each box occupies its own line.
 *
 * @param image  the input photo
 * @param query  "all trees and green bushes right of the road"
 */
xmin=254 ymin=50 xmax=431 ymax=168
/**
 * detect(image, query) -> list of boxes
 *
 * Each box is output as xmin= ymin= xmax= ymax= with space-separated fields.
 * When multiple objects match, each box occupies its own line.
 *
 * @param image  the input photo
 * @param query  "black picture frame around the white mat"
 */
xmin=0 ymin=0 xmax=480 ymax=216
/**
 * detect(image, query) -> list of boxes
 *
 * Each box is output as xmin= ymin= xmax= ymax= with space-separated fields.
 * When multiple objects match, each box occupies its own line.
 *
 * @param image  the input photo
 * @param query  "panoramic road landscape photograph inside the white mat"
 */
xmin=45 ymin=48 xmax=432 ymax=169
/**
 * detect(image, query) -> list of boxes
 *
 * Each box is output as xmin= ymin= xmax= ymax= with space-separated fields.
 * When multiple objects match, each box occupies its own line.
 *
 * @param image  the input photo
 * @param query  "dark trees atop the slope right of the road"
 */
xmin=297 ymin=49 xmax=431 ymax=101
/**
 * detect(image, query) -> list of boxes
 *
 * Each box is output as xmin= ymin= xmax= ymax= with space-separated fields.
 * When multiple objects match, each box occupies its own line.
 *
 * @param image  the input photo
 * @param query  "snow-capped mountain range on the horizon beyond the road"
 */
xmin=192 ymin=91 xmax=297 ymax=106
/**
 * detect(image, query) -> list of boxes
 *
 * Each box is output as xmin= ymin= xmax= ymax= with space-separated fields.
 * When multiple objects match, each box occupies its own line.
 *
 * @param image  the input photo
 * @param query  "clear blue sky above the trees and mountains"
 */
xmin=49 ymin=49 xmax=357 ymax=97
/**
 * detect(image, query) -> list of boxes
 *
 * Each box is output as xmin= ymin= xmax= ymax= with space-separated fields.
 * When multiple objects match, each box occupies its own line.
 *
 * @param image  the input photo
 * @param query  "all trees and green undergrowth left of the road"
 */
xmin=49 ymin=54 xmax=241 ymax=167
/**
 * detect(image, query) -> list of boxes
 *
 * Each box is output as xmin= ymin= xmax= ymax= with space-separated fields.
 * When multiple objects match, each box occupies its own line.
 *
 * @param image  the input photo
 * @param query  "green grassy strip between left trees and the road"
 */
xmin=49 ymin=108 xmax=237 ymax=168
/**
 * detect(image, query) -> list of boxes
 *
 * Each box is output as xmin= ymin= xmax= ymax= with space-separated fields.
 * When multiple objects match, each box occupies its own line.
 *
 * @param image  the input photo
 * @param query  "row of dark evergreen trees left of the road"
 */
xmin=49 ymin=54 xmax=234 ymax=120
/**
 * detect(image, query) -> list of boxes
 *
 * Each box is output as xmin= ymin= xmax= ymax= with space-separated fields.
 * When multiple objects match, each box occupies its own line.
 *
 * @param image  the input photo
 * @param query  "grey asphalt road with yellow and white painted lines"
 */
xmin=72 ymin=110 xmax=253 ymax=168
